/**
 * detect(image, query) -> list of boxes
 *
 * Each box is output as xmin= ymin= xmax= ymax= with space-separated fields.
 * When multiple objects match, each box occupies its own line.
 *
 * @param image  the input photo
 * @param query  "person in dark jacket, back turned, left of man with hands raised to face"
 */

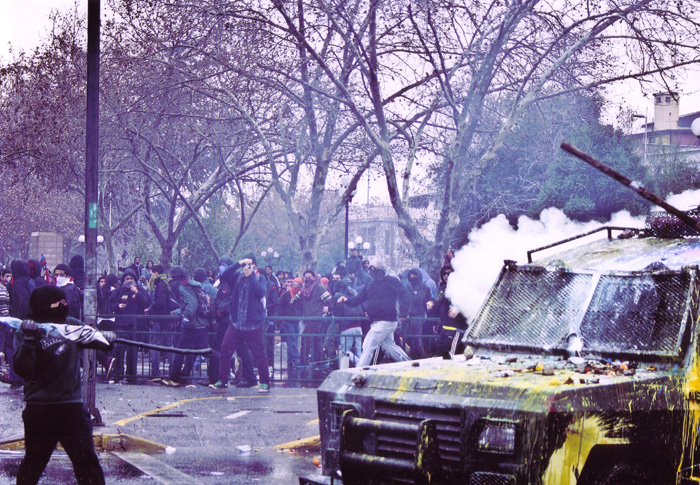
xmin=163 ymin=266 xmax=209 ymax=387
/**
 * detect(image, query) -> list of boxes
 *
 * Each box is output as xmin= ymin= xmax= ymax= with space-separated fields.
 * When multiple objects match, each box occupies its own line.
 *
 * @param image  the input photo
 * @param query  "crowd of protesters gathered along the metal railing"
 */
xmin=0 ymin=249 xmax=467 ymax=392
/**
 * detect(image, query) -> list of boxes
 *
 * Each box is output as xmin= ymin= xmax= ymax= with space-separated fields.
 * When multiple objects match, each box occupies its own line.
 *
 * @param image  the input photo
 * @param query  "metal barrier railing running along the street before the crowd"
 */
xmin=97 ymin=315 xmax=438 ymax=385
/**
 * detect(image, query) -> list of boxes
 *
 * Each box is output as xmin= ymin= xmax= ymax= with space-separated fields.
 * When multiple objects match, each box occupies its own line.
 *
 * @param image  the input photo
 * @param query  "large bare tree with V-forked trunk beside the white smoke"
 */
xmin=266 ymin=0 xmax=700 ymax=274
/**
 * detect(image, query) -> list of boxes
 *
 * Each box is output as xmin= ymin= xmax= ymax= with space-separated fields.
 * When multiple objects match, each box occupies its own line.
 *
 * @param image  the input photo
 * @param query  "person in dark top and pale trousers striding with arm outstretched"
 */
xmin=337 ymin=257 xmax=411 ymax=367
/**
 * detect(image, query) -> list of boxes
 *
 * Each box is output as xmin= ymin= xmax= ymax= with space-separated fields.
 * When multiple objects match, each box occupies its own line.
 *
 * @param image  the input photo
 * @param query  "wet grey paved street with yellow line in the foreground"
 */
xmin=0 ymin=384 xmax=320 ymax=484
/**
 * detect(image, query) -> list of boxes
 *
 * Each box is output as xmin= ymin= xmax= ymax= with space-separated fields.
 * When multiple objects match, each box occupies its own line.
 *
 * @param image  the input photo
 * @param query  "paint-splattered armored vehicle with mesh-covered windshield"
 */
xmin=302 ymin=221 xmax=700 ymax=485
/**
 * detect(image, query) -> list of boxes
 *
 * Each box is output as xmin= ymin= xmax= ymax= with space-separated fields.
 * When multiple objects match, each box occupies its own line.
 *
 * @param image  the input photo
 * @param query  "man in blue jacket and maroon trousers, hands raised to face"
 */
xmin=216 ymin=257 xmax=270 ymax=392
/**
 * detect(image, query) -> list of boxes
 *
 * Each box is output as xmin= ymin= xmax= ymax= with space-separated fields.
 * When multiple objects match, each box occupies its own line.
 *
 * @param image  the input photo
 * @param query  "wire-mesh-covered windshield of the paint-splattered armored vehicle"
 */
xmin=467 ymin=266 xmax=693 ymax=356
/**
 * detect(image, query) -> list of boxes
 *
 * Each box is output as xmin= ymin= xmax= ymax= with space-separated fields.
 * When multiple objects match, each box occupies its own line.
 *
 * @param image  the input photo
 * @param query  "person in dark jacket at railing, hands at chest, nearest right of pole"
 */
xmin=110 ymin=269 xmax=151 ymax=384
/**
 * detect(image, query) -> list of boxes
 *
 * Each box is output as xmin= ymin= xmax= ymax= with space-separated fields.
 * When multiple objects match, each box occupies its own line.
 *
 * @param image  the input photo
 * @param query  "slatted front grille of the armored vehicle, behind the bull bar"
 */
xmin=374 ymin=401 xmax=462 ymax=471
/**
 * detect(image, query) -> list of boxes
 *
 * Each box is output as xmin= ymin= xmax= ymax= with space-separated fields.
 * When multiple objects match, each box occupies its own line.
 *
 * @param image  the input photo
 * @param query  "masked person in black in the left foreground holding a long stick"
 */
xmin=14 ymin=285 xmax=116 ymax=484
